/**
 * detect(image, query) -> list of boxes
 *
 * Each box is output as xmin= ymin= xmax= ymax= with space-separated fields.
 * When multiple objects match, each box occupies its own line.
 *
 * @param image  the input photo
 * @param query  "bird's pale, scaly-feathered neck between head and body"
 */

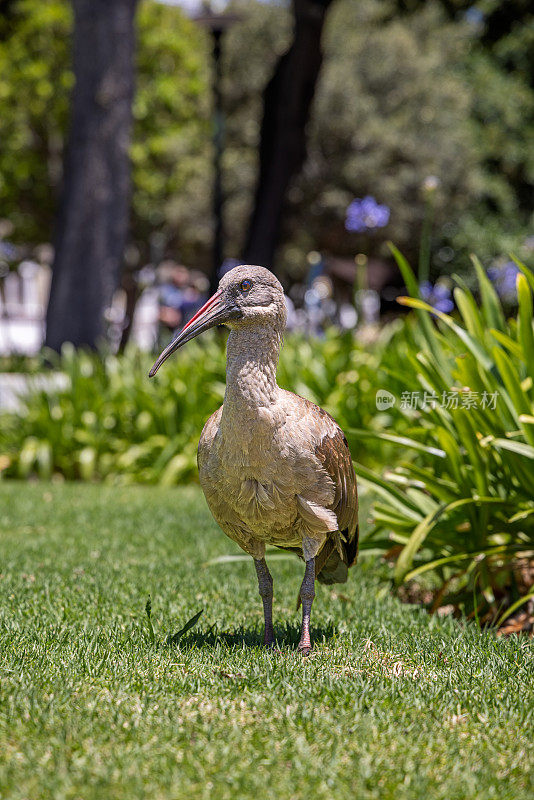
xmin=223 ymin=325 xmax=282 ymax=421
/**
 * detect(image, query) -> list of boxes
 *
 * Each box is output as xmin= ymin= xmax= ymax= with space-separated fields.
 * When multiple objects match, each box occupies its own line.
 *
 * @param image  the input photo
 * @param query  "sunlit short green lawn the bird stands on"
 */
xmin=0 ymin=483 xmax=534 ymax=800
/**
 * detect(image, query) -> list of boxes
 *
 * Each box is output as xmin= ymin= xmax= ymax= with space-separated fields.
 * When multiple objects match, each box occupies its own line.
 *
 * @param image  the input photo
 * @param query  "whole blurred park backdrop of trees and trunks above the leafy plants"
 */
xmin=0 ymin=0 xmax=534 ymax=355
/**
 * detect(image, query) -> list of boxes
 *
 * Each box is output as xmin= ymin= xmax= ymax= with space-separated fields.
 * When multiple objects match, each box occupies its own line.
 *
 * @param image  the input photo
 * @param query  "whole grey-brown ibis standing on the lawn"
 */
xmin=149 ymin=265 xmax=358 ymax=655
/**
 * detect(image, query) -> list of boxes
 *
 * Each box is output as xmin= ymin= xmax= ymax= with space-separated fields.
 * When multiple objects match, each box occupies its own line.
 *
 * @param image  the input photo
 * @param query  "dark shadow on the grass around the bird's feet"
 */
xmin=167 ymin=622 xmax=337 ymax=649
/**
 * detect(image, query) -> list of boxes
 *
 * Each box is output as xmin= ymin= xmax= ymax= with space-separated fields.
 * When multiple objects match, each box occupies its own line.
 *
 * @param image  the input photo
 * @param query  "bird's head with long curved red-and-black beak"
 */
xmin=148 ymin=265 xmax=286 ymax=378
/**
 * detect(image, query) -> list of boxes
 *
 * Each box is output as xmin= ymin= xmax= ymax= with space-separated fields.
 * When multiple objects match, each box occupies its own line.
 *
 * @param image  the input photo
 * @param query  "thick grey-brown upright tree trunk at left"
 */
xmin=46 ymin=0 xmax=137 ymax=350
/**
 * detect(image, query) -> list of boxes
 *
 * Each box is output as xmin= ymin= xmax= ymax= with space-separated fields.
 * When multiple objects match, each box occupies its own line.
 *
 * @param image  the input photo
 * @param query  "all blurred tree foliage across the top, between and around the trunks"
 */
xmin=0 ymin=0 xmax=534 ymax=275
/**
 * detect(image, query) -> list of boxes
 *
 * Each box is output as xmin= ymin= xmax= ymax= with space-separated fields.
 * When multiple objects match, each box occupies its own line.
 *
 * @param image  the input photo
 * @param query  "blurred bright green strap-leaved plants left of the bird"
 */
xmin=2 ymin=338 xmax=224 ymax=484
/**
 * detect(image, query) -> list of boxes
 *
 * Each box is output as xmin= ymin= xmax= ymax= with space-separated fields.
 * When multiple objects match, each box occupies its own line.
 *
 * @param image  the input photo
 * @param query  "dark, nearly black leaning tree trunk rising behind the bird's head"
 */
xmin=244 ymin=0 xmax=332 ymax=267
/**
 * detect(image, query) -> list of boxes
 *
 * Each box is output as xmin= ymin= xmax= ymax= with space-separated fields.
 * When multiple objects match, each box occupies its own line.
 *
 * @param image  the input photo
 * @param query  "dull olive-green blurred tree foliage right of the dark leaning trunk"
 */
xmin=297 ymin=0 xmax=480 ymax=268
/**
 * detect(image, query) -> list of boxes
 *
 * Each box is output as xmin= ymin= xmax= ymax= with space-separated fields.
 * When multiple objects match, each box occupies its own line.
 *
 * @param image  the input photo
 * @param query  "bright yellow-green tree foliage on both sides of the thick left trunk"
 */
xmin=0 ymin=0 xmax=211 ymax=257
